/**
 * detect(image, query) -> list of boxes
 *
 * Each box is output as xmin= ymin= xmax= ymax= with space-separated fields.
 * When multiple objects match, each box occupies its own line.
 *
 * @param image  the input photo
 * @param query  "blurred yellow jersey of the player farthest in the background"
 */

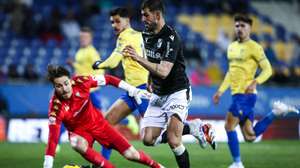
xmin=73 ymin=45 xmax=104 ymax=76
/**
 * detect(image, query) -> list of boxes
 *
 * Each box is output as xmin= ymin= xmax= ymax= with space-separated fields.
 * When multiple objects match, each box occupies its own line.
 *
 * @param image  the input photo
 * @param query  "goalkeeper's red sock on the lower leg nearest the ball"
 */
xmin=82 ymin=147 xmax=115 ymax=168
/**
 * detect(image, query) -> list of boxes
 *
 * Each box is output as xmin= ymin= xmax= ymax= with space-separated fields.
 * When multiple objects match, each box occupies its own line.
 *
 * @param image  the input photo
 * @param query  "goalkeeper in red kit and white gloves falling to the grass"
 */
xmin=43 ymin=65 xmax=163 ymax=168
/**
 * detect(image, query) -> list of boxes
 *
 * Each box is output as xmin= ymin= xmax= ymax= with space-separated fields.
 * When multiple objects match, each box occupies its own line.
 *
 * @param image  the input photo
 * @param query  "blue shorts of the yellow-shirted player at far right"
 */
xmin=229 ymin=94 xmax=256 ymax=123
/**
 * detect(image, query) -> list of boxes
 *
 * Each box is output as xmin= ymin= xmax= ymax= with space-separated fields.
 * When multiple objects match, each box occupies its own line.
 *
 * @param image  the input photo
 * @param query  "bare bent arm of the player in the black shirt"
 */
xmin=122 ymin=45 xmax=174 ymax=79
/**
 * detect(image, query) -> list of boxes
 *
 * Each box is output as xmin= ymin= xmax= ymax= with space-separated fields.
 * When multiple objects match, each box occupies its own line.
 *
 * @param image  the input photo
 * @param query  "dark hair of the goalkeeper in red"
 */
xmin=47 ymin=64 xmax=70 ymax=83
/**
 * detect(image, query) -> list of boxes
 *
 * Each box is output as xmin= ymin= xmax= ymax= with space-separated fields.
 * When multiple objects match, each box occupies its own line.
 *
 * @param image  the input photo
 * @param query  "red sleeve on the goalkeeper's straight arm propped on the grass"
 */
xmin=46 ymin=97 xmax=63 ymax=156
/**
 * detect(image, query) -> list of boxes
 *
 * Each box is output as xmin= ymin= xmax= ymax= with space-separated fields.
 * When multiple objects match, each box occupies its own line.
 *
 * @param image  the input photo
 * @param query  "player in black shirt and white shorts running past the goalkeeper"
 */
xmin=123 ymin=0 xmax=216 ymax=168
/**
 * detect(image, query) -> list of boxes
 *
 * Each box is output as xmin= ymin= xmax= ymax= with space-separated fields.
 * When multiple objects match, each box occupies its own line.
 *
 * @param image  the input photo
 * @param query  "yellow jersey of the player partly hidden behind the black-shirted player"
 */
xmin=99 ymin=28 xmax=148 ymax=86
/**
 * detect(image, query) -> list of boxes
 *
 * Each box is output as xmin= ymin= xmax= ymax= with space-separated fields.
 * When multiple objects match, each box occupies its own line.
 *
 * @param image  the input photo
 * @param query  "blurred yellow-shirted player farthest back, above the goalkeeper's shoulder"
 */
xmin=69 ymin=27 xmax=104 ymax=109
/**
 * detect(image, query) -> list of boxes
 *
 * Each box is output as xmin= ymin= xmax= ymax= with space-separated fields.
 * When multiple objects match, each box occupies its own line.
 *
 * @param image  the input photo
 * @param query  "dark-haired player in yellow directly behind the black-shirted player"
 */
xmin=93 ymin=8 xmax=148 ymax=159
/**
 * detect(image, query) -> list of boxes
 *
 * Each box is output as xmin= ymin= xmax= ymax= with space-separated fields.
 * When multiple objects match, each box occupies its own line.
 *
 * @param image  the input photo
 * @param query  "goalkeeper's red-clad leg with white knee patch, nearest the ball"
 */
xmin=69 ymin=132 xmax=114 ymax=168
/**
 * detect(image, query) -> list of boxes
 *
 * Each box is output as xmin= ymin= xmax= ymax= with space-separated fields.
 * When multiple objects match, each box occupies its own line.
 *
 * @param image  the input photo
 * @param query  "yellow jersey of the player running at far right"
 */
xmin=219 ymin=39 xmax=272 ymax=95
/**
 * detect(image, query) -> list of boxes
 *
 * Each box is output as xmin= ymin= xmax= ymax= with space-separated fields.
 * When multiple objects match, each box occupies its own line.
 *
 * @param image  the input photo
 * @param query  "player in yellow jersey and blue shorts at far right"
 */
xmin=213 ymin=15 xmax=297 ymax=168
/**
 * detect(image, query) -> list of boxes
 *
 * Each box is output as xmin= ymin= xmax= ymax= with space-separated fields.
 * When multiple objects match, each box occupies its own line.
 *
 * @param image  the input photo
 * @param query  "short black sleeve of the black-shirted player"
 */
xmin=162 ymin=34 xmax=180 ymax=63
